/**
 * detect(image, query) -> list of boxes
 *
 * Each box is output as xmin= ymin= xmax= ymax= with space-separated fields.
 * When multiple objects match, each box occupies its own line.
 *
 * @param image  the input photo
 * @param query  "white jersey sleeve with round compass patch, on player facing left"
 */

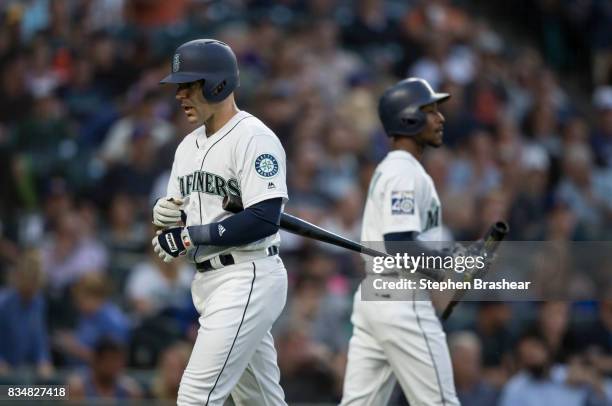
xmin=234 ymin=133 xmax=288 ymax=208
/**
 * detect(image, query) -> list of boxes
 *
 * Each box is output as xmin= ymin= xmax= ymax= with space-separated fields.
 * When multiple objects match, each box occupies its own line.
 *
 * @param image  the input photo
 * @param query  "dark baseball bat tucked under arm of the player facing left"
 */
xmin=223 ymin=195 xmax=444 ymax=282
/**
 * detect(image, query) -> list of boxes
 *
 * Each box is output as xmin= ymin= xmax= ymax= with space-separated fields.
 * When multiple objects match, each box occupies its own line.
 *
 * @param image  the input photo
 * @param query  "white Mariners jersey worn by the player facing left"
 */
xmin=167 ymin=111 xmax=288 ymax=262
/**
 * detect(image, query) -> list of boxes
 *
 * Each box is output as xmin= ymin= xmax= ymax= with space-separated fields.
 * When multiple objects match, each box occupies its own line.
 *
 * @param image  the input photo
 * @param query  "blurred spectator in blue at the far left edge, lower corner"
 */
xmin=0 ymin=250 xmax=53 ymax=377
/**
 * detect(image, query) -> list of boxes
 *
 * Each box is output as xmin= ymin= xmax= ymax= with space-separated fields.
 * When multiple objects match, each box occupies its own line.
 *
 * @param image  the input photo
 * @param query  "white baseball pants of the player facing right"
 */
xmin=341 ymin=288 xmax=459 ymax=406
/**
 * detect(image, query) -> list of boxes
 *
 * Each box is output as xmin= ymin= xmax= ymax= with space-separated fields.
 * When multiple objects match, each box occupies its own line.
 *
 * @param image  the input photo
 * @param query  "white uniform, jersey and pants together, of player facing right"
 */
xmin=341 ymin=150 xmax=459 ymax=406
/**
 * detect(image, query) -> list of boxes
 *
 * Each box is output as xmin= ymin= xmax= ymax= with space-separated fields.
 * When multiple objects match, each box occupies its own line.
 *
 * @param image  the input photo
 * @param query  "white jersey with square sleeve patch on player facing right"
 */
xmin=361 ymin=150 xmax=442 ymax=242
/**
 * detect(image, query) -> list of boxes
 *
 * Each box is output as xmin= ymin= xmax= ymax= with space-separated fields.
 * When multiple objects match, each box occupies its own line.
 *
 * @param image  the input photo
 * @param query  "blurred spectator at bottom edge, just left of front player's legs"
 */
xmin=151 ymin=342 xmax=191 ymax=400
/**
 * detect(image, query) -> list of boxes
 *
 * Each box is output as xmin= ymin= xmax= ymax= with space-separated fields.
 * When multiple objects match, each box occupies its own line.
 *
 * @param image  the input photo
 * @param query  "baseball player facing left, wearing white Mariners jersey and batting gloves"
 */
xmin=152 ymin=39 xmax=287 ymax=406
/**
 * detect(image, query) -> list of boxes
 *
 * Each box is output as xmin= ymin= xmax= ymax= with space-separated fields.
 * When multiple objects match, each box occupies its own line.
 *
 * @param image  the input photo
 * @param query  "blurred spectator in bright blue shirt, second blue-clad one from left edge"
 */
xmin=53 ymin=273 xmax=130 ymax=364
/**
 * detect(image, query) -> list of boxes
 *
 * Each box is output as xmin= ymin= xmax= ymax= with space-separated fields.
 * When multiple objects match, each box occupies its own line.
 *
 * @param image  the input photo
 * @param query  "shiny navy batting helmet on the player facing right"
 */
xmin=378 ymin=78 xmax=450 ymax=135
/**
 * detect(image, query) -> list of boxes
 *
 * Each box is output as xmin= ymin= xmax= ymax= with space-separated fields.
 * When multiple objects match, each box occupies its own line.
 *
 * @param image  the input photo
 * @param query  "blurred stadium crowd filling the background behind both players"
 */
xmin=0 ymin=0 xmax=612 ymax=406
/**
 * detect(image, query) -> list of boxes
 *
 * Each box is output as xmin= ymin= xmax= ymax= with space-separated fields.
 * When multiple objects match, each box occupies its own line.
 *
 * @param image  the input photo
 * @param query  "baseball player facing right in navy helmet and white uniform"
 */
xmin=342 ymin=78 xmax=459 ymax=406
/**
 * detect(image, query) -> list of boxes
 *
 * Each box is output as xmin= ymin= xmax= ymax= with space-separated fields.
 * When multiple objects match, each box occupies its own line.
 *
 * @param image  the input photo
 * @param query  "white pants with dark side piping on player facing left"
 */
xmin=177 ymin=256 xmax=287 ymax=406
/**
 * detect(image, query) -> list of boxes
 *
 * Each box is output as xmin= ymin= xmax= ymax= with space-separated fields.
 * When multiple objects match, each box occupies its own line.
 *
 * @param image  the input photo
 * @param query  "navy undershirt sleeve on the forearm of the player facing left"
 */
xmin=187 ymin=197 xmax=283 ymax=246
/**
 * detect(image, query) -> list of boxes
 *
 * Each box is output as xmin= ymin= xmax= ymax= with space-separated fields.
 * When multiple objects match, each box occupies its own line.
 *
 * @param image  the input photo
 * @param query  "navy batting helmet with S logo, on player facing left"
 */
xmin=160 ymin=39 xmax=239 ymax=103
